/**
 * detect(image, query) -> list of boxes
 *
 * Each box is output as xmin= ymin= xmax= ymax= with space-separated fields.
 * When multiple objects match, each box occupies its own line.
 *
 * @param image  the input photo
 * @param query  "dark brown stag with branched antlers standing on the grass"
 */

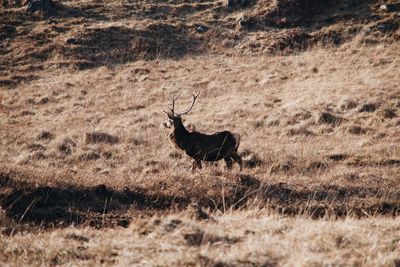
xmin=163 ymin=93 xmax=243 ymax=171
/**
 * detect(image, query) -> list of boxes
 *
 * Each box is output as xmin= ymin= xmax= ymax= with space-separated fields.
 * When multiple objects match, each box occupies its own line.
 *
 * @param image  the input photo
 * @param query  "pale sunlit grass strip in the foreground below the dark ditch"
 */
xmin=0 ymin=213 xmax=400 ymax=267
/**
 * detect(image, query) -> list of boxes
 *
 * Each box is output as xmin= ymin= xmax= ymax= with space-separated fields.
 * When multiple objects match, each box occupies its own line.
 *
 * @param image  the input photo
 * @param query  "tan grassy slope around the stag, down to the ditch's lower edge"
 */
xmin=0 ymin=42 xmax=400 ymax=232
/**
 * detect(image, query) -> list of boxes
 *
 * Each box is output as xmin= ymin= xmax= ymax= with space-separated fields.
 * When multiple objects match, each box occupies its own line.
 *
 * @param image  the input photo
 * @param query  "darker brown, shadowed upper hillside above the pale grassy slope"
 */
xmin=0 ymin=0 xmax=400 ymax=87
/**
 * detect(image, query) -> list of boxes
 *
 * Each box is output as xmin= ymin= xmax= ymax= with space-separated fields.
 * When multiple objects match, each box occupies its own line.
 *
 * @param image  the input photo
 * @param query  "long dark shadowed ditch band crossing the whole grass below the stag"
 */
xmin=0 ymin=174 xmax=400 ymax=228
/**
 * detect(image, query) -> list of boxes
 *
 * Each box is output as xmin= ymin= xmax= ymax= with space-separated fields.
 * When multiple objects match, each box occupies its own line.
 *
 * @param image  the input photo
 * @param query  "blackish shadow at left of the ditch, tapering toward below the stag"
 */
xmin=0 ymin=176 xmax=189 ymax=228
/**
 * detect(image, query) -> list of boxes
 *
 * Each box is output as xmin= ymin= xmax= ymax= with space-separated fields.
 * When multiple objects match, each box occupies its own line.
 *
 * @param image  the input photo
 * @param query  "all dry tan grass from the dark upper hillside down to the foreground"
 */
xmin=1 ymin=43 xmax=400 ymax=266
